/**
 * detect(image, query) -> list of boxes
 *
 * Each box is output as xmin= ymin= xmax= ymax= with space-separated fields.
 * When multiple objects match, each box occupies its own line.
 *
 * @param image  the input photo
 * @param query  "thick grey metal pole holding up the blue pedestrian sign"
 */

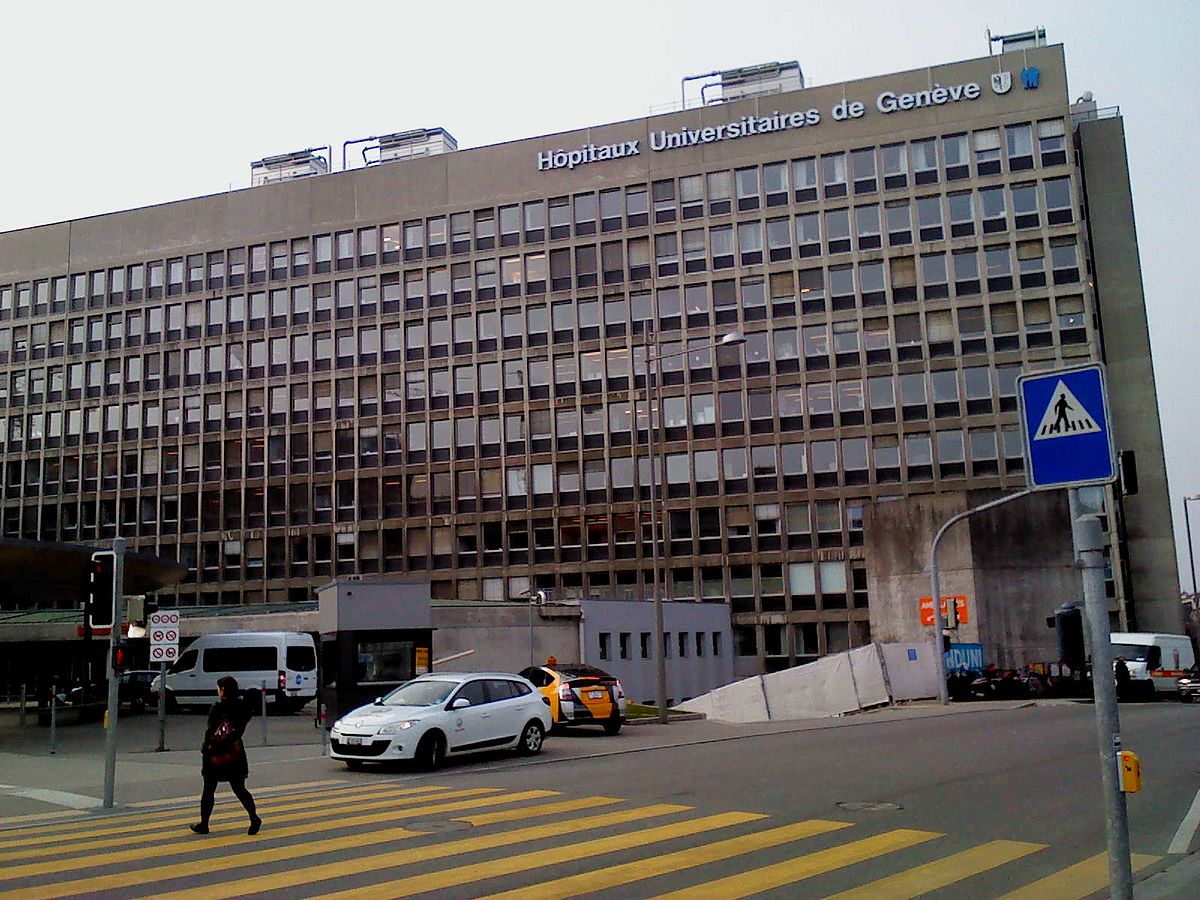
xmin=1070 ymin=496 xmax=1133 ymax=900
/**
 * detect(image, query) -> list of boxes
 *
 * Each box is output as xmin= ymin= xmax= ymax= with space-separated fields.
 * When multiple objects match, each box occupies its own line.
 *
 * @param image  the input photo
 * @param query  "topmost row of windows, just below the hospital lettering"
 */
xmin=0 ymin=119 xmax=1069 ymax=319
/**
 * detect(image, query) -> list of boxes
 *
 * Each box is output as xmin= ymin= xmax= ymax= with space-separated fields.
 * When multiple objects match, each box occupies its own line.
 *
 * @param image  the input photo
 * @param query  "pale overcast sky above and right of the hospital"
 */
xmin=0 ymin=0 xmax=1200 ymax=590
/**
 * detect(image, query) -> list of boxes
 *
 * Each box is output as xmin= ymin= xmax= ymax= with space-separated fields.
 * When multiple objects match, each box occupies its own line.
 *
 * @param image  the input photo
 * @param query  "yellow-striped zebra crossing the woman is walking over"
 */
xmin=0 ymin=781 xmax=1159 ymax=900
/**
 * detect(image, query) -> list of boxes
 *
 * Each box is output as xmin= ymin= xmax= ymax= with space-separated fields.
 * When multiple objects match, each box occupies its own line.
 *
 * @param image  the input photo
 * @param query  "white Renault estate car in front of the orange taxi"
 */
xmin=329 ymin=672 xmax=551 ymax=769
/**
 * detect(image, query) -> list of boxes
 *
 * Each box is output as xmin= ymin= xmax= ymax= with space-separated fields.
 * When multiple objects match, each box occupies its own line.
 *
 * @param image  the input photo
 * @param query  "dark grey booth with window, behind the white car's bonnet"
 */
xmin=317 ymin=577 xmax=433 ymax=725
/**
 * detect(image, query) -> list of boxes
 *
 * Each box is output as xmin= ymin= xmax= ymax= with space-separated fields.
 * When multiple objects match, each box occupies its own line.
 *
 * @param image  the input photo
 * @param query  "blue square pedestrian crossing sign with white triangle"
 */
xmin=1016 ymin=362 xmax=1117 ymax=490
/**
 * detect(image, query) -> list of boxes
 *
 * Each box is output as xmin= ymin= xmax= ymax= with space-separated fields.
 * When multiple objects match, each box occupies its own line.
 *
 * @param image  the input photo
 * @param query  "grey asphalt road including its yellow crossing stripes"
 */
xmin=0 ymin=703 xmax=1200 ymax=900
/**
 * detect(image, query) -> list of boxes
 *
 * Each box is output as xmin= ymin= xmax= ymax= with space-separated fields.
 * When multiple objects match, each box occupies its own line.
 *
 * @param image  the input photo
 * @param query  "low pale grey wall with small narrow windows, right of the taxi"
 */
xmin=576 ymin=600 xmax=733 ymax=703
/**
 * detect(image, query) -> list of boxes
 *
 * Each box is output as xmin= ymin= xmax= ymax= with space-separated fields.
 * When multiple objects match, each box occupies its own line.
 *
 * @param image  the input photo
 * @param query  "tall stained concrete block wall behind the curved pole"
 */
xmin=864 ymin=491 xmax=1082 ymax=666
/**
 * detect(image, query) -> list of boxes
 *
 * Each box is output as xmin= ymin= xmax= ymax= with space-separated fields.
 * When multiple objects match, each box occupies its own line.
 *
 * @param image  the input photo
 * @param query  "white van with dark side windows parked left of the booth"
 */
xmin=151 ymin=631 xmax=317 ymax=712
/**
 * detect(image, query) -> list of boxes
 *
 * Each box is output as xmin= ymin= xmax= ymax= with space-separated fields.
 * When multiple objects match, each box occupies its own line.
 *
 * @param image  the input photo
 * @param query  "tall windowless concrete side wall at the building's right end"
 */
xmin=1078 ymin=118 xmax=1193 ymax=634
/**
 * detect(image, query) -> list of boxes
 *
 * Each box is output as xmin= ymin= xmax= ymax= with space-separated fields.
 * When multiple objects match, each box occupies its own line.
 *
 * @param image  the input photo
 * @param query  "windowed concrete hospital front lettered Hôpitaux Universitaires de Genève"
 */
xmin=0 ymin=47 xmax=1177 ymax=673
